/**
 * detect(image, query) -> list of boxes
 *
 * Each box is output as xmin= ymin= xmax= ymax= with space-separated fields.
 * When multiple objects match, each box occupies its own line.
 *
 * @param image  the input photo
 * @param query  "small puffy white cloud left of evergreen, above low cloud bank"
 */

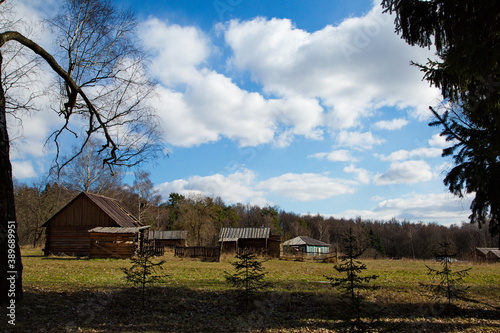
xmin=374 ymin=161 xmax=433 ymax=185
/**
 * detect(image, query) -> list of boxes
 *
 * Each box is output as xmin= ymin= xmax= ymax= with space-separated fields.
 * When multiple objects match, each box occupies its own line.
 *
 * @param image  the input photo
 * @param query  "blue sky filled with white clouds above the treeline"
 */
xmin=12 ymin=0 xmax=470 ymax=224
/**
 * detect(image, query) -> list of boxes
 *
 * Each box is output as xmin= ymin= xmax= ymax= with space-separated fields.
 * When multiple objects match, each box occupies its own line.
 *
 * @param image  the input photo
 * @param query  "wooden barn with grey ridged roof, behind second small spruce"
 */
xmin=219 ymin=227 xmax=281 ymax=258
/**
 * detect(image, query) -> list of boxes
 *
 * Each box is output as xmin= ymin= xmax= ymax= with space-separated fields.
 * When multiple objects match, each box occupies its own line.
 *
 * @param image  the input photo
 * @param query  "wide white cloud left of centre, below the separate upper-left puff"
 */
xmin=151 ymin=71 xmax=323 ymax=147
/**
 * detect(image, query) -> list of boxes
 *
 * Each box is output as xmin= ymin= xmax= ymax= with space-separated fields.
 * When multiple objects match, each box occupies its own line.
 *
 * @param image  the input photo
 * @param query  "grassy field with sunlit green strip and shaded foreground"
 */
xmin=0 ymin=249 xmax=500 ymax=332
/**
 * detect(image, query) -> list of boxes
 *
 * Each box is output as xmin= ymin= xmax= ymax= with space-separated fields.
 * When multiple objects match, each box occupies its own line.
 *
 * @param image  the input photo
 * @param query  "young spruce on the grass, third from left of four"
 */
xmin=326 ymin=228 xmax=378 ymax=332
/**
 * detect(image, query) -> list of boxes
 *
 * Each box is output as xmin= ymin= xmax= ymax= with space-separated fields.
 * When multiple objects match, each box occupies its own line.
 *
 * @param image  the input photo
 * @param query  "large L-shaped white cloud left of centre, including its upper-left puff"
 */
xmin=141 ymin=19 xmax=324 ymax=147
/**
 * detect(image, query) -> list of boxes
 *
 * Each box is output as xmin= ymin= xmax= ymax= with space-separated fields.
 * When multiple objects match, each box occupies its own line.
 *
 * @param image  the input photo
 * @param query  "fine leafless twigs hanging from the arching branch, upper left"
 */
xmin=49 ymin=0 xmax=161 ymax=168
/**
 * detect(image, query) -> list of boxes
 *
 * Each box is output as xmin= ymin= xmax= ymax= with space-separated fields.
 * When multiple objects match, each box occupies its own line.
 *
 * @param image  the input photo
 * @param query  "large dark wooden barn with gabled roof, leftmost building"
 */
xmin=42 ymin=192 xmax=142 ymax=256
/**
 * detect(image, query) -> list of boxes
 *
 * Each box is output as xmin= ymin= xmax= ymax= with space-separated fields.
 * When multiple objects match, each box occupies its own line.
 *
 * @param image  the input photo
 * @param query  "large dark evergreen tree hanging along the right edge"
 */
xmin=382 ymin=0 xmax=500 ymax=246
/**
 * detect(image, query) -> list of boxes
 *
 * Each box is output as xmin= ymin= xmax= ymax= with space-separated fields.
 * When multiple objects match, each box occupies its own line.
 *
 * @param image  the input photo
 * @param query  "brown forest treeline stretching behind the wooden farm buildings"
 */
xmin=15 ymin=171 xmax=496 ymax=259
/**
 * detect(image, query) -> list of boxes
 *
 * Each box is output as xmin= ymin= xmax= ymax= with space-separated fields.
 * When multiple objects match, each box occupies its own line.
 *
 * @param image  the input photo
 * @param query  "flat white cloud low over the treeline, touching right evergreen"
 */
xmin=335 ymin=193 xmax=471 ymax=224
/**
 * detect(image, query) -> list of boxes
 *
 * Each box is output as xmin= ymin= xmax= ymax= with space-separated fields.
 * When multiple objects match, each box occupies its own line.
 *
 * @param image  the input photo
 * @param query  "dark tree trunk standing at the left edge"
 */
xmin=0 ymin=52 xmax=23 ymax=304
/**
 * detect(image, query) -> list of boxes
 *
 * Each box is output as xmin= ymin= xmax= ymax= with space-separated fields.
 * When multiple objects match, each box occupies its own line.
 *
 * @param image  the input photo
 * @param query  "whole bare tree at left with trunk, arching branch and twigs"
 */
xmin=0 ymin=0 xmax=159 ymax=303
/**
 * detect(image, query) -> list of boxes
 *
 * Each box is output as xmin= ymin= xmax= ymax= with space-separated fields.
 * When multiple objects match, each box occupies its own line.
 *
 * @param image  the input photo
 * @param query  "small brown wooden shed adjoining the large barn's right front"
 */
xmin=89 ymin=226 xmax=149 ymax=259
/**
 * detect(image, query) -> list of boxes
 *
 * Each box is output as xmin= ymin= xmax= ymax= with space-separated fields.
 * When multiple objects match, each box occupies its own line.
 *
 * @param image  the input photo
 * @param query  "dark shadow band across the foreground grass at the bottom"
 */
xmin=0 ymin=287 xmax=500 ymax=332
